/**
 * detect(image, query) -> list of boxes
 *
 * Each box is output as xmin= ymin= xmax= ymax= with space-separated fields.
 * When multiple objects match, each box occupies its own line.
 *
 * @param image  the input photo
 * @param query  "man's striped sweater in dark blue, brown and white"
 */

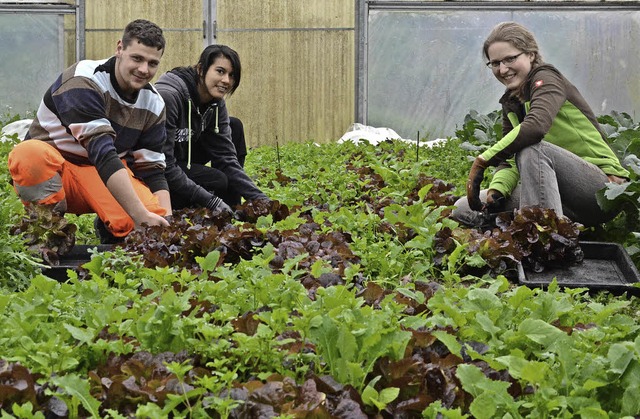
xmin=26 ymin=57 xmax=168 ymax=192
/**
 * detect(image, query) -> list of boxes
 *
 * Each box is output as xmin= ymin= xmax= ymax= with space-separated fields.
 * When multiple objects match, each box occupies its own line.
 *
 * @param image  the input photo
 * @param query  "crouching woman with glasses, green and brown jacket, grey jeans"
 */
xmin=452 ymin=22 xmax=629 ymax=226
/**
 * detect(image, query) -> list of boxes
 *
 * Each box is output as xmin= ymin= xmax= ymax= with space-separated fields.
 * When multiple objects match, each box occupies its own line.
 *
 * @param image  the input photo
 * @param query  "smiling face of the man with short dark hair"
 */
xmin=116 ymin=39 xmax=164 ymax=96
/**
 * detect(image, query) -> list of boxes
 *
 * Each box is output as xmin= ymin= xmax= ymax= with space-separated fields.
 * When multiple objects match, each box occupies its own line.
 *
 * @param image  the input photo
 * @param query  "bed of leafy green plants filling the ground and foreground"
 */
xmin=0 ymin=113 xmax=640 ymax=418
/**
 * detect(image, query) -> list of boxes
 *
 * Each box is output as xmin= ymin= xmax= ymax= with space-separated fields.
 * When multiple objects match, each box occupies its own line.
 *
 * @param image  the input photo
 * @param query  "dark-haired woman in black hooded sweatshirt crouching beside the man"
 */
xmin=155 ymin=45 xmax=268 ymax=211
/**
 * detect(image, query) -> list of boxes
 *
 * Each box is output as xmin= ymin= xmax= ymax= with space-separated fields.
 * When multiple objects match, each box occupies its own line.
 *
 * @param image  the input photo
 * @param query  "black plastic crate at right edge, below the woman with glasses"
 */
xmin=518 ymin=242 xmax=640 ymax=295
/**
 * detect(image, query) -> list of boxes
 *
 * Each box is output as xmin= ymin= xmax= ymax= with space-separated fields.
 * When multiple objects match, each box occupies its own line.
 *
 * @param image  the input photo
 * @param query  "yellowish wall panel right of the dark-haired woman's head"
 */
xmin=218 ymin=0 xmax=355 ymax=145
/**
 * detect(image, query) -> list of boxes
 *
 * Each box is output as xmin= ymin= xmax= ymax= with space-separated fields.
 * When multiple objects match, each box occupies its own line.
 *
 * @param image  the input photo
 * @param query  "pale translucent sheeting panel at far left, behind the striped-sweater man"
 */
xmin=0 ymin=13 xmax=64 ymax=116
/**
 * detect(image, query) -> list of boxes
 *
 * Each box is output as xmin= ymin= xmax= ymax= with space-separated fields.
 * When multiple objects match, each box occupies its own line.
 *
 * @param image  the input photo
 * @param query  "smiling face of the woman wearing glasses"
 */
xmin=487 ymin=42 xmax=535 ymax=90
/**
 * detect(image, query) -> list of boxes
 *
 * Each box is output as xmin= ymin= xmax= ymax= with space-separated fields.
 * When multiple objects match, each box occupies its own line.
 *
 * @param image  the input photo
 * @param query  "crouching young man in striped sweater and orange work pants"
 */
xmin=8 ymin=19 xmax=171 ymax=243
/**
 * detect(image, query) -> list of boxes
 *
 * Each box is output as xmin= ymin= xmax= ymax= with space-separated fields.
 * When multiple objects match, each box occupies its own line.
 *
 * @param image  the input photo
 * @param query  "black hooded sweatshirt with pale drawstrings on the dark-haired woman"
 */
xmin=155 ymin=67 xmax=268 ymax=206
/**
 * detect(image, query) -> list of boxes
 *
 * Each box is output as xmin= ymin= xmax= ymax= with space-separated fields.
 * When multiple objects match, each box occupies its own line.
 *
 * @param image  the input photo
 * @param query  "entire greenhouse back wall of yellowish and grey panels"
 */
xmin=0 ymin=0 xmax=640 ymax=146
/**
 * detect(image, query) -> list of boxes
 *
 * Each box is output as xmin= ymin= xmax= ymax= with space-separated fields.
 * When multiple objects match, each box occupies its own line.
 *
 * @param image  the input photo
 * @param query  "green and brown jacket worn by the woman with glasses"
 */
xmin=481 ymin=64 xmax=629 ymax=196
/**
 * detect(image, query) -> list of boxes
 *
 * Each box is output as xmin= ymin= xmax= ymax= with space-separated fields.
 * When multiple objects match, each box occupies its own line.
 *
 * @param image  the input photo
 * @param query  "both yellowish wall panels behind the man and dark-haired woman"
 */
xmin=81 ymin=0 xmax=355 ymax=146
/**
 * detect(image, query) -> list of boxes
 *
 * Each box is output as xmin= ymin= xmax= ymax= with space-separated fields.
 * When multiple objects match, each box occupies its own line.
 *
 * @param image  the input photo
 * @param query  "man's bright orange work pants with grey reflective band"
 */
xmin=8 ymin=140 xmax=167 ymax=237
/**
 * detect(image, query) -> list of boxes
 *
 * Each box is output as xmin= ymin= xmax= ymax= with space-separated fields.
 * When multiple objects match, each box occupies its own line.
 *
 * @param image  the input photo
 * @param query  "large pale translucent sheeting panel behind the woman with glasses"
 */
xmin=366 ymin=10 xmax=640 ymax=139
